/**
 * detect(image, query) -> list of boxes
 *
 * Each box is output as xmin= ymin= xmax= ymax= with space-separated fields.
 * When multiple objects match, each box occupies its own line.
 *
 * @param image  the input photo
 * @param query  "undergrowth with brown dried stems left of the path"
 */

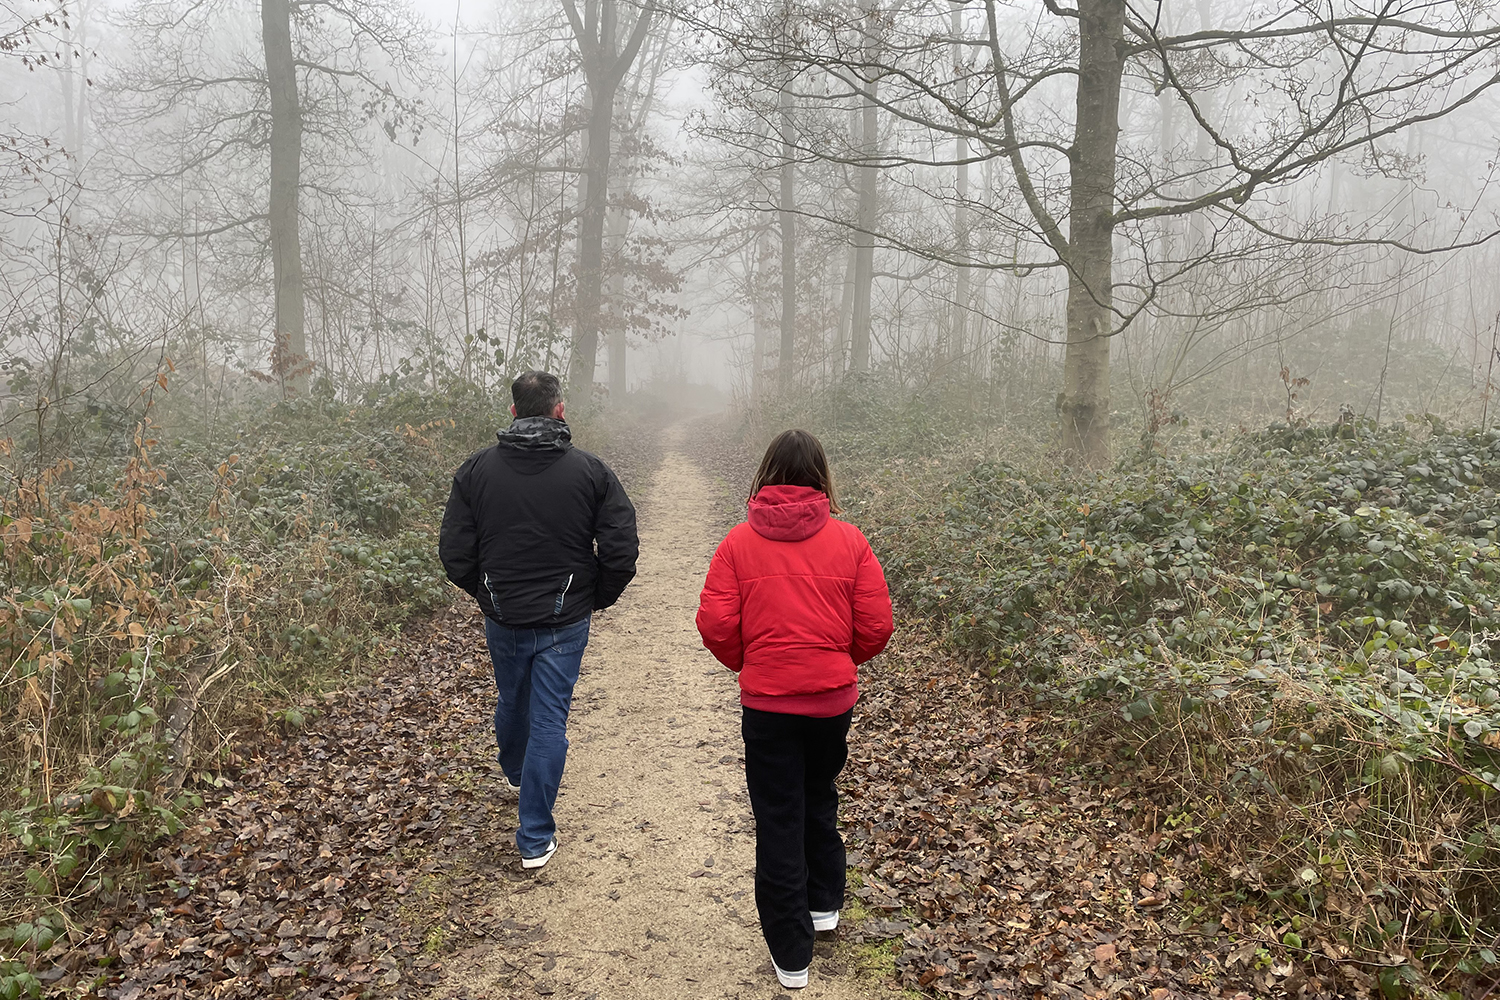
xmin=0 ymin=381 xmax=528 ymax=997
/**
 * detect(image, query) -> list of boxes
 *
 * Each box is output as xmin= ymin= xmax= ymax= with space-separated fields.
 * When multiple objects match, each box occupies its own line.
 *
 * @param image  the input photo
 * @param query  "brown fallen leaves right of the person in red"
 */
xmin=840 ymin=630 xmax=1376 ymax=1000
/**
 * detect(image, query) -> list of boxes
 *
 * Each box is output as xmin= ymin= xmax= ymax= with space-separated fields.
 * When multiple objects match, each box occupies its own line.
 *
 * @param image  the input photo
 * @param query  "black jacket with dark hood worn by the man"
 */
xmin=438 ymin=417 xmax=641 ymax=628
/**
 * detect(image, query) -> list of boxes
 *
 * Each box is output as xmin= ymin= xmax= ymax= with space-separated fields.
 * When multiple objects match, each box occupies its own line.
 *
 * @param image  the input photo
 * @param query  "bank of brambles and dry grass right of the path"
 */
xmin=747 ymin=381 xmax=1500 ymax=997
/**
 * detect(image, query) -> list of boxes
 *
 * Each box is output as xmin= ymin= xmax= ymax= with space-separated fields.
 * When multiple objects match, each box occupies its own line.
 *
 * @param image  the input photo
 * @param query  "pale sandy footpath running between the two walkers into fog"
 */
xmin=438 ymin=436 xmax=885 ymax=1000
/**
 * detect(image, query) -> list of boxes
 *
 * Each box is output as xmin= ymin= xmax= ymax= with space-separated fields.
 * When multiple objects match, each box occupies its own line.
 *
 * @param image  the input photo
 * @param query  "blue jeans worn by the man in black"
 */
xmin=485 ymin=618 xmax=590 ymax=858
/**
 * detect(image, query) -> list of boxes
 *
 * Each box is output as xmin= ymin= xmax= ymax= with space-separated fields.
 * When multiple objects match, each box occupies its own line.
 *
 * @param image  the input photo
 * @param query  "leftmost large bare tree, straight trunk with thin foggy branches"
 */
xmin=102 ymin=0 xmax=422 ymax=394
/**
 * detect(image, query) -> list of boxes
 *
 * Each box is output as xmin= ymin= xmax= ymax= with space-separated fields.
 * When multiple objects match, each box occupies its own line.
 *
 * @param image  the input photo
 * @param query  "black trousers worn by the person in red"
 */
xmin=741 ymin=708 xmax=854 ymax=972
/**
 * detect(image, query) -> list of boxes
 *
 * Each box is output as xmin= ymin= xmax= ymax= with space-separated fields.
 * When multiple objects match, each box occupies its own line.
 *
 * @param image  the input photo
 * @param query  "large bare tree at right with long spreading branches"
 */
xmin=702 ymin=0 xmax=1500 ymax=465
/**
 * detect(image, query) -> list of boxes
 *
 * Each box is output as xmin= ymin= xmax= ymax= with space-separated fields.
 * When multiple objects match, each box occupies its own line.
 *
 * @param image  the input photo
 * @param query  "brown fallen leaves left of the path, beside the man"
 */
xmin=50 ymin=607 xmax=540 ymax=1000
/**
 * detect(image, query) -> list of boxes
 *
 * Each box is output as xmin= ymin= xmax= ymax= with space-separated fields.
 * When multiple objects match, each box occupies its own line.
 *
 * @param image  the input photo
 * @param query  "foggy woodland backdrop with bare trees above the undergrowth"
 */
xmin=0 ymin=0 xmax=1500 ymax=463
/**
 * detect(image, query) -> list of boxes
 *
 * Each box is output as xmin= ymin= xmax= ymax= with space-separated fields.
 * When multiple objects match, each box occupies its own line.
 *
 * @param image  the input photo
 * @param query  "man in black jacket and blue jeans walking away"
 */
xmin=438 ymin=372 xmax=639 ymax=868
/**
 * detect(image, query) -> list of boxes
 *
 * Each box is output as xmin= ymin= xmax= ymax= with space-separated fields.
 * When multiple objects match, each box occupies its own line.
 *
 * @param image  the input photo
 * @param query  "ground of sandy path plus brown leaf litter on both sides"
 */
xmin=70 ymin=427 xmax=1284 ymax=1000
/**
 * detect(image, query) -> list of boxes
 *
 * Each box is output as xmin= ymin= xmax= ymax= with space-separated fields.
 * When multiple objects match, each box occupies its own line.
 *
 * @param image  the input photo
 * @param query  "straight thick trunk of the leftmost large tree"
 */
xmin=261 ymin=0 xmax=311 ymax=396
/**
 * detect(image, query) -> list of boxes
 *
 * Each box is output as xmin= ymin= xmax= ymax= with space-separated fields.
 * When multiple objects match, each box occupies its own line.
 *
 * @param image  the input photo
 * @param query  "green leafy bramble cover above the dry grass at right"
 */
xmin=879 ymin=430 xmax=1500 ymax=773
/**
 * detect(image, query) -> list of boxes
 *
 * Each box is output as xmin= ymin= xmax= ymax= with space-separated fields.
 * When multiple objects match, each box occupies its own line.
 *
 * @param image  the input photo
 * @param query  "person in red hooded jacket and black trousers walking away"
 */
xmin=698 ymin=430 xmax=891 ymax=988
